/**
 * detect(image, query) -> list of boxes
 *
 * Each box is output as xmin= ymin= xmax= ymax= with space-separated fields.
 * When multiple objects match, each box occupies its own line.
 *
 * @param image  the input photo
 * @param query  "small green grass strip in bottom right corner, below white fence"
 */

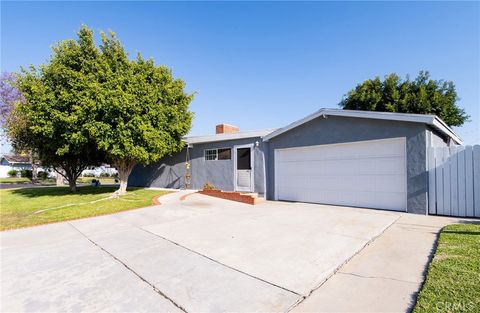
xmin=414 ymin=224 xmax=480 ymax=313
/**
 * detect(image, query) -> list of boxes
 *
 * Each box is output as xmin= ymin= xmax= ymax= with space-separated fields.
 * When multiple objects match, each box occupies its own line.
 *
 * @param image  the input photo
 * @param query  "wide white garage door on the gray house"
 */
xmin=275 ymin=138 xmax=407 ymax=211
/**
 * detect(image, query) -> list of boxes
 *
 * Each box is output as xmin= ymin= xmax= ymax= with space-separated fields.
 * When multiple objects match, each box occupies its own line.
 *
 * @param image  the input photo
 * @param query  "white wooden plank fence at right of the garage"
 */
xmin=428 ymin=145 xmax=480 ymax=217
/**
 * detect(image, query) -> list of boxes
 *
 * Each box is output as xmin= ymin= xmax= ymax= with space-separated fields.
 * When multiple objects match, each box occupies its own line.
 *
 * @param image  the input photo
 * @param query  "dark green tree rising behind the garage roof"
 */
xmin=340 ymin=71 xmax=469 ymax=126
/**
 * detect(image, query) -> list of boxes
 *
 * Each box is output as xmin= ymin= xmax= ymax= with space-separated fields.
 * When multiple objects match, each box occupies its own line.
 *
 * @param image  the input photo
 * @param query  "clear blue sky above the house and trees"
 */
xmin=1 ymin=1 xmax=480 ymax=153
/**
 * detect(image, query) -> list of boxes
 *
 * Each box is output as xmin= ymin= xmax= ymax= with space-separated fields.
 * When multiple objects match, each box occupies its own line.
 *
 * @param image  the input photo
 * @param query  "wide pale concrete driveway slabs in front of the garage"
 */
xmin=1 ymin=192 xmax=466 ymax=312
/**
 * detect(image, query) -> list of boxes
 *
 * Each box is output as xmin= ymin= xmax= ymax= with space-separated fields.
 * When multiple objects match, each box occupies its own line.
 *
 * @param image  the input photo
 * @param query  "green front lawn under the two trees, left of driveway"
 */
xmin=0 ymin=186 xmax=168 ymax=230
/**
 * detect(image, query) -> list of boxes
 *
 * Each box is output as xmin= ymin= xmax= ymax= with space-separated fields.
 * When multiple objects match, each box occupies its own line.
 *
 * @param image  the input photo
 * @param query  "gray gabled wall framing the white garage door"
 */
xmin=267 ymin=116 xmax=428 ymax=214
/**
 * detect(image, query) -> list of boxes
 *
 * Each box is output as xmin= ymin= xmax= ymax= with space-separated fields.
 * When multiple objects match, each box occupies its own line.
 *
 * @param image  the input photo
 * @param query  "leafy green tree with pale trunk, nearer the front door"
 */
xmin=93 ymin=32 xmax=193 ymax=194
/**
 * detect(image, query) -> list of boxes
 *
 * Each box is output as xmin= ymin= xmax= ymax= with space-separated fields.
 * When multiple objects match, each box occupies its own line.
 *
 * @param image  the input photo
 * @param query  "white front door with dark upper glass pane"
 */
xmin=234 ymin=145 xmax=254 ymax=192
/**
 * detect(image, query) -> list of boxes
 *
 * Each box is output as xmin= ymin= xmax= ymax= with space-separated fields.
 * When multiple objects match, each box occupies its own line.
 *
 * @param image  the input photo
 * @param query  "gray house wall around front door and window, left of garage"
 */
xmin=129 ymin=137 xmax=265 ymax=194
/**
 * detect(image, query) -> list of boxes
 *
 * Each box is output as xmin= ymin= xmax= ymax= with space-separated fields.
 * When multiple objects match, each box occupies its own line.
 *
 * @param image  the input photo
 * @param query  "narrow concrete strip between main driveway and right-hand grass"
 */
xmin=291 ymin=214 xmax=472 ymax=312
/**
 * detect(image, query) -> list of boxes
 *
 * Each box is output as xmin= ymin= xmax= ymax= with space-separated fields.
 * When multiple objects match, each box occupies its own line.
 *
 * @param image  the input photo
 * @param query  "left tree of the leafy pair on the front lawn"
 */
xmin=13 ymin=28 xmax=105 ymax=192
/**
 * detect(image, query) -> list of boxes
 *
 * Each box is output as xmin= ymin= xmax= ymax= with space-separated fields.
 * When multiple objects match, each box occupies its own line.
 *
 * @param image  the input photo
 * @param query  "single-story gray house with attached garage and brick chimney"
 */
xmin=129 ymin=109 xmax=462 ymax=214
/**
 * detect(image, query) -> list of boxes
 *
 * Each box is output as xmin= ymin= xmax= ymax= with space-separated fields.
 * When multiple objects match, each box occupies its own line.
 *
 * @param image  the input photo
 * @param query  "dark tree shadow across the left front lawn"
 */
xmin=10 ymin=186 xmax=139 ymax=198
